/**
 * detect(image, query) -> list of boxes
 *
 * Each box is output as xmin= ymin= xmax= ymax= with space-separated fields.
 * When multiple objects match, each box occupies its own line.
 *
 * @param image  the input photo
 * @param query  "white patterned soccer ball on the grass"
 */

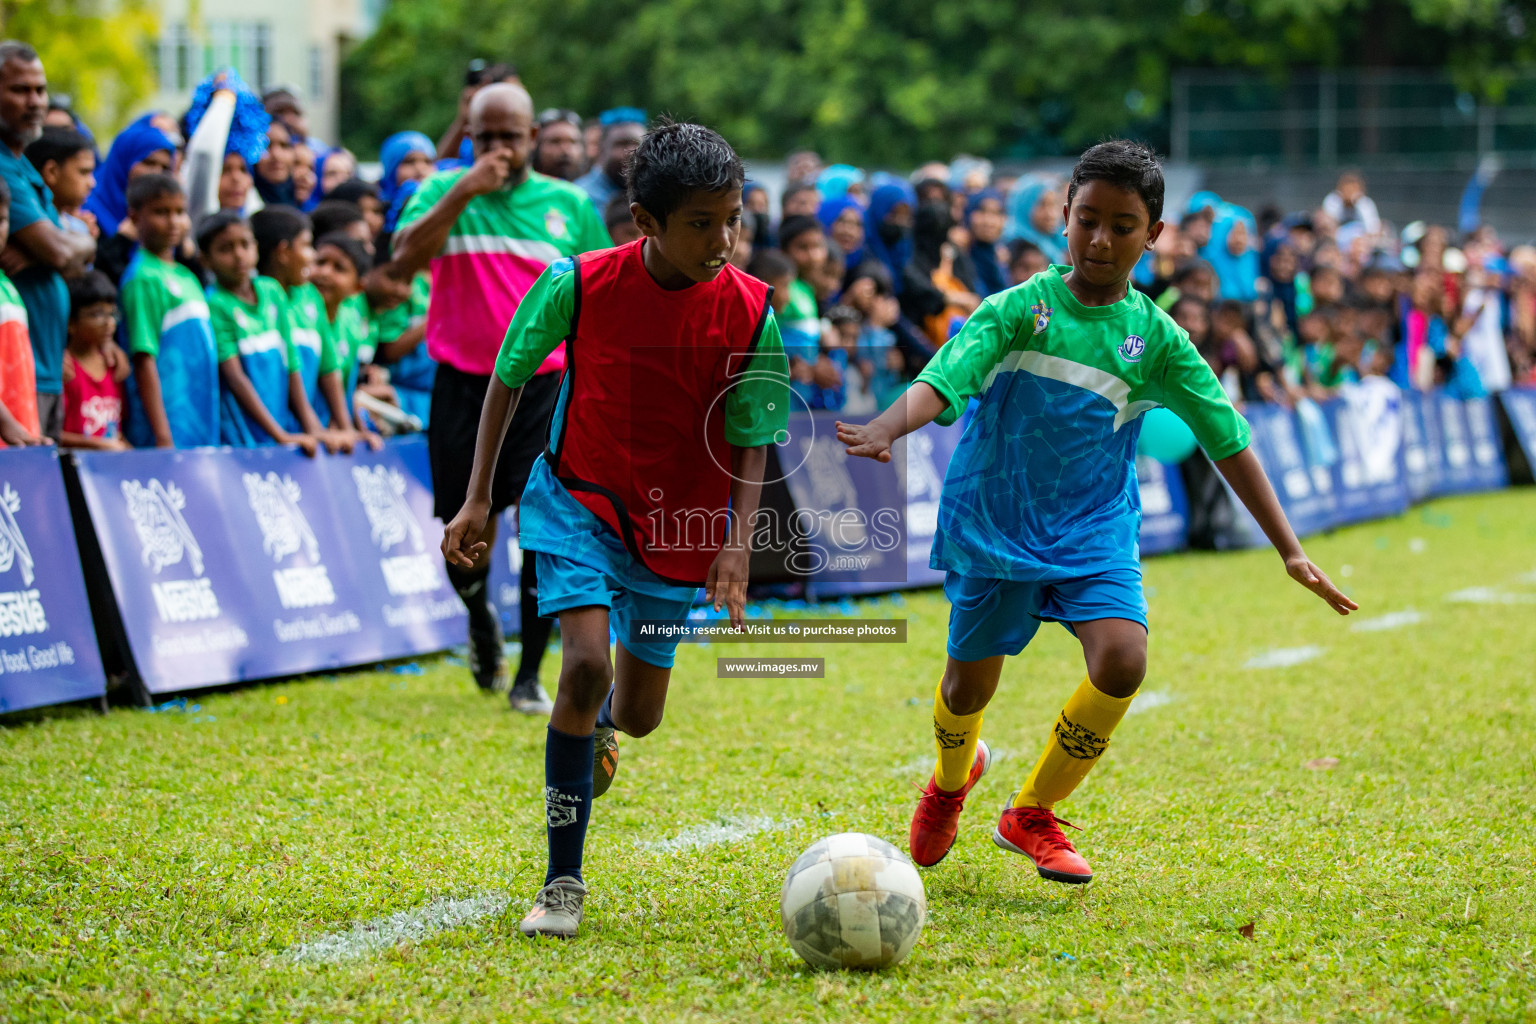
xmin=779 ymin=832 xmax=928 ymax=970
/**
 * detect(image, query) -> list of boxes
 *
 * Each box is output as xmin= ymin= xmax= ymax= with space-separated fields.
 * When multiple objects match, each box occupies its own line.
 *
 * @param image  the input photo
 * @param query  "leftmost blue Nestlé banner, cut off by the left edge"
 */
xmin=0 ymin=448 xmax=106 ymax=711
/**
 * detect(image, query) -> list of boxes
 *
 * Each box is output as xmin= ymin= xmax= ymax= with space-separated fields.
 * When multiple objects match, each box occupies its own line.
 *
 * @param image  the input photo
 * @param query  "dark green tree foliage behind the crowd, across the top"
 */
xmin=343 ymin=0 xmax=1536 ymax=164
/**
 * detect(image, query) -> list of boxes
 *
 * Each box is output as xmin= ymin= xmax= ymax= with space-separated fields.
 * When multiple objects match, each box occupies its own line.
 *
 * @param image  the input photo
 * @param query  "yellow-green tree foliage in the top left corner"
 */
xmin=0 ymin=0 xmax=157 ymax=138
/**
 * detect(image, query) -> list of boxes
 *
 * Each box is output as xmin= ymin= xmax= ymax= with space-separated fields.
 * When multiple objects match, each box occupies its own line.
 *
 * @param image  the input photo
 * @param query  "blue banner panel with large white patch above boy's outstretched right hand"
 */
xmin=1322 ymin=378 xmax=1409 ymax=524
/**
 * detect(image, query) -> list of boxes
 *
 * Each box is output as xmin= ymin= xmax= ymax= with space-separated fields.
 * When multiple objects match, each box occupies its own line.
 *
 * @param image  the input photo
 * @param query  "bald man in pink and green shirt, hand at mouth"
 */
xmin=392 ymin=83 xmax=613 ymax=714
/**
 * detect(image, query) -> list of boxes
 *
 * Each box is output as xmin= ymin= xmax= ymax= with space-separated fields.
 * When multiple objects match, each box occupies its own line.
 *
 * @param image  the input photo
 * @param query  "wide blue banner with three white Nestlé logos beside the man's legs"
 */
xmin=77 ymin=439 xmax=465 ymax=692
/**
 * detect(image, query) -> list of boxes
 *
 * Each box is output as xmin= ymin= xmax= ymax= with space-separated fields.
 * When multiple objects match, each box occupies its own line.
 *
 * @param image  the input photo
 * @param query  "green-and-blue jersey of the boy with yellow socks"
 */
xmin=917 ymin=267 xmax=1250 ymax=582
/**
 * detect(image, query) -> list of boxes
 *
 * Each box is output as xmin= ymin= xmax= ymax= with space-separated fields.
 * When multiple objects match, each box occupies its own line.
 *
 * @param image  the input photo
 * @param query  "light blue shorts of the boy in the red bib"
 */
xmin=518 ymin=456 xmax=699 ymax=668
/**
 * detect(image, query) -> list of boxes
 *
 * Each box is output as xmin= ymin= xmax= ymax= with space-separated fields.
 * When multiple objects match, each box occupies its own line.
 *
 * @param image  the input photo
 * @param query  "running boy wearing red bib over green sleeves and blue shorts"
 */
xmin=442 ymin=124 xmax=790 ymax=938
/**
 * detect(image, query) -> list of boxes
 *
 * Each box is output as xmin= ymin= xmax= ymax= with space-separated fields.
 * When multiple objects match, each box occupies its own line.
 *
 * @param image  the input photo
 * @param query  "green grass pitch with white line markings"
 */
xmin=0 ymin=490 xmax=1536 ymax=1022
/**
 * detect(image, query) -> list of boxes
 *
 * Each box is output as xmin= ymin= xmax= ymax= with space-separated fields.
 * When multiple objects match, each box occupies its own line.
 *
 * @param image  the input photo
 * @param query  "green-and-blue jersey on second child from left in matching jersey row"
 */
xmin=207 ymin=278 xmax=296 ymax=447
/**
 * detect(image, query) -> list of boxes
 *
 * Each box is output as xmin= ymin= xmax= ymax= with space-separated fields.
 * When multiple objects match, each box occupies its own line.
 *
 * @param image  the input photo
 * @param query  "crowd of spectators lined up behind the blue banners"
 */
xmin=0 ymin=41 xmax=1536 ymax=451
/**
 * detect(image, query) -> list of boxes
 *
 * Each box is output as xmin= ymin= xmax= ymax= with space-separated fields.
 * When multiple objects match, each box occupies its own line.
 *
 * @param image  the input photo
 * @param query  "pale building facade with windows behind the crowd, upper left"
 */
xmin=151 ymin=0 xmax=378 ymax=141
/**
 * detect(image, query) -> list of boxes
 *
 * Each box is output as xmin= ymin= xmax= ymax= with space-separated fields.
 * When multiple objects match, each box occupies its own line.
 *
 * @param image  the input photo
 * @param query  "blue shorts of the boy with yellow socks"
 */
xmin=940 ymin=567 xmax=1147 ymax=662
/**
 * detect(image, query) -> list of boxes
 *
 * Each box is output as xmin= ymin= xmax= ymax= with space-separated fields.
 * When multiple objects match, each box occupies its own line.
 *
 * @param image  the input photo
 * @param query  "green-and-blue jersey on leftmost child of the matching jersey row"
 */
xmin=123 ymin=249 xmax=218 ymax=448
